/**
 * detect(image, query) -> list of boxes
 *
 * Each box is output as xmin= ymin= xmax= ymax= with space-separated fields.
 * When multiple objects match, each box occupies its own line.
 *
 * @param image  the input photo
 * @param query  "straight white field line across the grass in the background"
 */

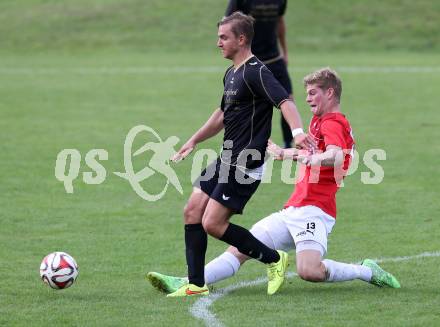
xmin=0 ymin=66 xmax=440 ymax=75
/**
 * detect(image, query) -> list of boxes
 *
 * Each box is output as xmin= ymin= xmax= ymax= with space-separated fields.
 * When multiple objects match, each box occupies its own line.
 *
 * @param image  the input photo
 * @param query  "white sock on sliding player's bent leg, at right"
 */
xmin=322 ymin=259 xmax=372 ymax=282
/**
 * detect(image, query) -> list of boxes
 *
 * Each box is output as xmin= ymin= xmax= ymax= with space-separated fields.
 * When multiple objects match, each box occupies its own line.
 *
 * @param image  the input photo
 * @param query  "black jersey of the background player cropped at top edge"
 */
xmin=226 ymin=0 xmax=287 ymax=61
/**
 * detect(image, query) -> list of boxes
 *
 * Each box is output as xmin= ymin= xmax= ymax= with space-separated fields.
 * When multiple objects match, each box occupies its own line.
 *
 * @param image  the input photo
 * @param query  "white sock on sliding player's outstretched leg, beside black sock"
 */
xmin=205 ymin=252 xmax=240 ymax=284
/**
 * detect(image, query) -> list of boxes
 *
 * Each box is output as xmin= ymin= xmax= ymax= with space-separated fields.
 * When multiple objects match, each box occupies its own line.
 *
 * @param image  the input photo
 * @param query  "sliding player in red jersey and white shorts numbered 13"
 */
xmin=150 ymin=68 xmax=400 ymax=292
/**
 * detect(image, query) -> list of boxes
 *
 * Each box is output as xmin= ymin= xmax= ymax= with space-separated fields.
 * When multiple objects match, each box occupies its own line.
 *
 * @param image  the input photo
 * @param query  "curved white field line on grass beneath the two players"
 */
xmin=189 ymin=251 xmax=440 ymax=327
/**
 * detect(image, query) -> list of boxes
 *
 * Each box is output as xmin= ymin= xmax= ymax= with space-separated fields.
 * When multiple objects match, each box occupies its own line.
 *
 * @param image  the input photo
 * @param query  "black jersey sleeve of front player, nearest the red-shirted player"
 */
xmin=245 ymin=65 xmax=290 ymax=109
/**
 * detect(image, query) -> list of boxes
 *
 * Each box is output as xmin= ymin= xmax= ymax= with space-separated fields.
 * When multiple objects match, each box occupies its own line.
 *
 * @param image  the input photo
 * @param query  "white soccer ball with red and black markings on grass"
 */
xmin=40 ymin=252 xmax=78 ymax=290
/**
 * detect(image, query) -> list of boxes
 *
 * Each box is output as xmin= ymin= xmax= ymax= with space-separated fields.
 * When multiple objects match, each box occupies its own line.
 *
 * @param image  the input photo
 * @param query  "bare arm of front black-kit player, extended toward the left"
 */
xmin=171 ymin=108 xmax=224 ymax=162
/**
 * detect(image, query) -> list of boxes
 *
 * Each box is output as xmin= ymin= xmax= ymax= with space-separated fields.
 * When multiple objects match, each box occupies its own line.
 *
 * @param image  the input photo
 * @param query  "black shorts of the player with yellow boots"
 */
xmin=193 ymin=158 xmax=261 ymax=214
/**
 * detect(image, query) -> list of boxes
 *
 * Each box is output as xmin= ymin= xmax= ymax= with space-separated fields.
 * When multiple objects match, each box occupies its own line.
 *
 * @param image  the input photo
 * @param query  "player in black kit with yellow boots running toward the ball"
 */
xmin=157 ymin=12 xmax=314 ymax=297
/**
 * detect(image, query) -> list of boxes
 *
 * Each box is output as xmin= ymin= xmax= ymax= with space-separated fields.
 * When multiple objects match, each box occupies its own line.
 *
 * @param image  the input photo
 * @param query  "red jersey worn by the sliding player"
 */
xmin=284 ymin=113 xmax=354 ymax=218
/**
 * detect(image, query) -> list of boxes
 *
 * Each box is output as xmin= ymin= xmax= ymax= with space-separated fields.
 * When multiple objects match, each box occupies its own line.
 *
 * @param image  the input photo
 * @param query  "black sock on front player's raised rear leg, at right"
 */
xmin=220 ymin=224 xmax=280 ymax=263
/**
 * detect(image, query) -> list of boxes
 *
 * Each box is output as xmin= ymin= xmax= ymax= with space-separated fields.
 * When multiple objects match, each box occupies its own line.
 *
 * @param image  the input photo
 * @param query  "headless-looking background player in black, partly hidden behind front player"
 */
xmin=225 ymin=0 xmax=292 ymax=148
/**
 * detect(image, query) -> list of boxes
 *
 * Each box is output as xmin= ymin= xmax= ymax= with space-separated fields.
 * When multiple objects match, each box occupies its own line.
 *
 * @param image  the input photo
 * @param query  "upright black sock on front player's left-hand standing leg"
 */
xmin=185 ymin=224 xmax=208 ymax=287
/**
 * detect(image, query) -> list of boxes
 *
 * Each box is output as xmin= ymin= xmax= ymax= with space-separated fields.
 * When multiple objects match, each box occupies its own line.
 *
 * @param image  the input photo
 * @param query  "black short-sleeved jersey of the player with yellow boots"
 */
xmin=220 ymin=56 xmax=289 ymax=169
